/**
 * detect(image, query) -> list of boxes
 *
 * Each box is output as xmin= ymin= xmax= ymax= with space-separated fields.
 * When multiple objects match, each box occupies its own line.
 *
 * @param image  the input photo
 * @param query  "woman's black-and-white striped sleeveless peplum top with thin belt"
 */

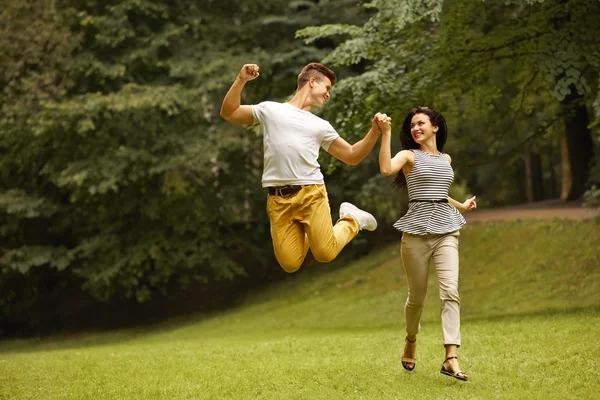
xmin=394 ymin=150 xmax=467 ymax=235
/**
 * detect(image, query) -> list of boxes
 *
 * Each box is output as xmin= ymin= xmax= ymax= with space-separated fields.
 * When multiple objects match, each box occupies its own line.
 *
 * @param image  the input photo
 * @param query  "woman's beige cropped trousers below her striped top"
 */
xmin=402 ymin=231 xmax=460 ymax=346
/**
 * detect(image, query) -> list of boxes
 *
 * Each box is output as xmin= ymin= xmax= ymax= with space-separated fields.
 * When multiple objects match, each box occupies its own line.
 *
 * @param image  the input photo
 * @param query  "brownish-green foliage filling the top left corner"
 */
xmin=0 ymin=0 xmax=78 ymax=122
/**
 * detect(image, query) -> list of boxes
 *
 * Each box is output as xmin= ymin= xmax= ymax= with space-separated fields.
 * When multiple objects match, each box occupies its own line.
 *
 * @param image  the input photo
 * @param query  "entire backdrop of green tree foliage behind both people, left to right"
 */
xmin=0 ymin=0 xmax=600 ymax=334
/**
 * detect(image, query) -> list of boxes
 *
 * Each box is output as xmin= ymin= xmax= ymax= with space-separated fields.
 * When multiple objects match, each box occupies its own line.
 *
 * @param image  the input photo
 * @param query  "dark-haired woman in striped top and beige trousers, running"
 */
xmin=379 ymin=107 xmax=477 ymax=381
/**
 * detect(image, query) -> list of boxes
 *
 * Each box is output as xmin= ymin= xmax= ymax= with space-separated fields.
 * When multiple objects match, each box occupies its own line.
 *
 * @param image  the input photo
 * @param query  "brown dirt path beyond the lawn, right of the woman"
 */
xmin=463 ymin=200 xmax=597 ymax=223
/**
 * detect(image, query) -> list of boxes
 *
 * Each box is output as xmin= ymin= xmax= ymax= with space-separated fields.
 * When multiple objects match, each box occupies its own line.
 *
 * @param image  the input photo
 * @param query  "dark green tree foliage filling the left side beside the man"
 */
xmin=0 ymin=0 xmax=370 ymax=332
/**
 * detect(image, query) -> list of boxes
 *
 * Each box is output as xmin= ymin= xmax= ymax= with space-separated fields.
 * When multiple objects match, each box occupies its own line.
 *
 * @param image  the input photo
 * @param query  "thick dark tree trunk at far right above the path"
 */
xmin=560 ymin=87 xmax=594 ymax=200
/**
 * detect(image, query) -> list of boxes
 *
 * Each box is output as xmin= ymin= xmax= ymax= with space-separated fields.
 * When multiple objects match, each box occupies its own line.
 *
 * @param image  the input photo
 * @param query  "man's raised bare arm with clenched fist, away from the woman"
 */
xmin=221 ymin=64 xmax=260 ymax=125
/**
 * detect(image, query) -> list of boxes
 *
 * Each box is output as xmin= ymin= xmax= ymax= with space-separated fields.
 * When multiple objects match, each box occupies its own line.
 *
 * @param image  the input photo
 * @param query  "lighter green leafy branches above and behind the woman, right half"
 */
xmin=298 ymin=0 xmax=600 ymax=205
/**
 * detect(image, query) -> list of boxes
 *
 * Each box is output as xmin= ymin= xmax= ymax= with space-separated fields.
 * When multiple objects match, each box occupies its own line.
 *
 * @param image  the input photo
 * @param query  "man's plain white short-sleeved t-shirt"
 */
xmin=252 ymin=101 xmax=340 ymax=187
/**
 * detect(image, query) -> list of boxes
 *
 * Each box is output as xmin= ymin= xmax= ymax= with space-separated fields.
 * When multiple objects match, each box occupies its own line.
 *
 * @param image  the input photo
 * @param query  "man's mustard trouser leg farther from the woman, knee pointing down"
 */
xmin=267 ymin=196 xmax=308 ymax=273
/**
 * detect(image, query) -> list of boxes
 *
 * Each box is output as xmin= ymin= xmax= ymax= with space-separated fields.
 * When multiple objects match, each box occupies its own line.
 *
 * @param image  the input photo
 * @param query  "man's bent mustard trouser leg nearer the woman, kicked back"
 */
xmin=298 ymin=185 xmax=360 ymax=262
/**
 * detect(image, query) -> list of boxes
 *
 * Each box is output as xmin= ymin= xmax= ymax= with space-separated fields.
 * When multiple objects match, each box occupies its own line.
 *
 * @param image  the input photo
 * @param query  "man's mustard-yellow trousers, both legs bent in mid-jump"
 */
xmin=267 ymin=185 xmax=360 ymax=272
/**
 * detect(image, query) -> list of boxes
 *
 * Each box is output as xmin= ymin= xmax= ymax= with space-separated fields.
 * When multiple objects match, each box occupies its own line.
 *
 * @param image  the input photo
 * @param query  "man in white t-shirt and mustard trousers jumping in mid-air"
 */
xmin=221 ymin=63 xmax=389 ymax=273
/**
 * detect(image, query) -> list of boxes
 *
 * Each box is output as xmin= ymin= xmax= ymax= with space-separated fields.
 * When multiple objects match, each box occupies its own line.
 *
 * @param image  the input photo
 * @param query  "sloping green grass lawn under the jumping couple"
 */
xmin=0 ymin=221 xmax=600 ymax=400
